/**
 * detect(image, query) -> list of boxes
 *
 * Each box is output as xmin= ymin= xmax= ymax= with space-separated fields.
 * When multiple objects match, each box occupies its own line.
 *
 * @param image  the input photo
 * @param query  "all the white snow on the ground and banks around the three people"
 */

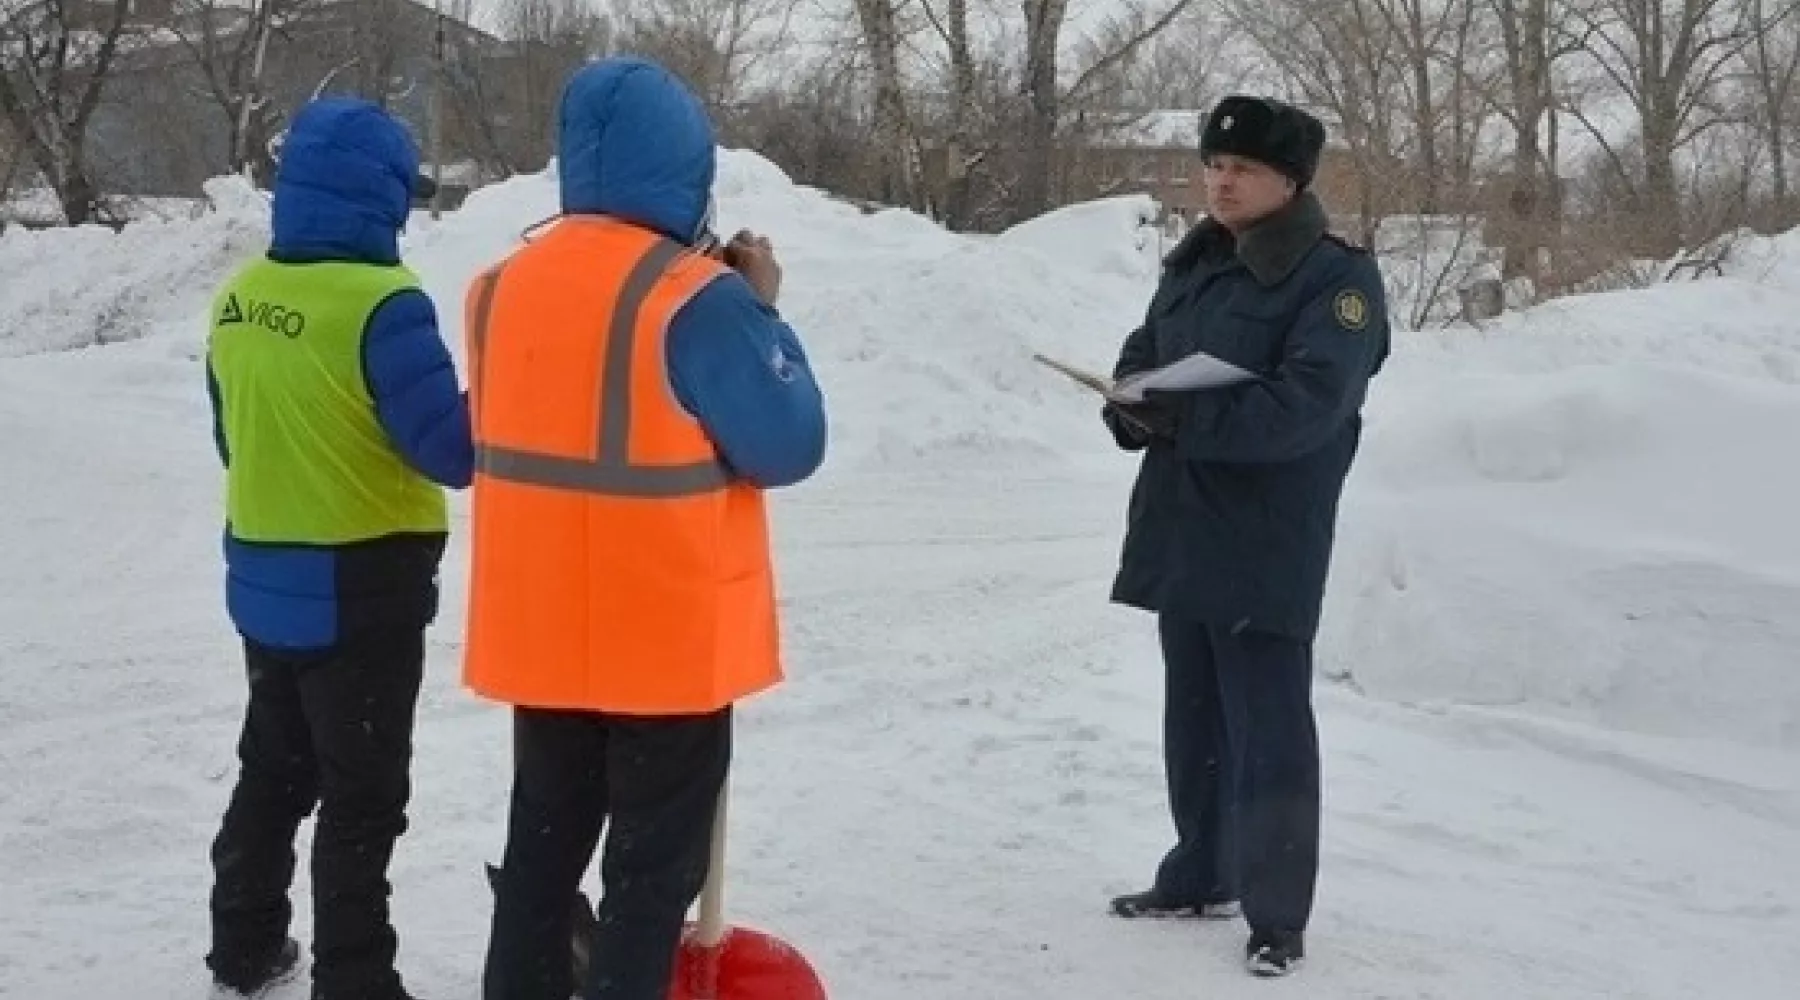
xmin=0 ymin=156 xmax=1800 ymax=1000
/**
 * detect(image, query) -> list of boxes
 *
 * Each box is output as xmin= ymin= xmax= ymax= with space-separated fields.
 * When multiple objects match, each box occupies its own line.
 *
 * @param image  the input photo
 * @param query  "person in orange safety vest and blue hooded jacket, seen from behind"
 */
xmin=464 ymin=58 xmax=826 ymax=1000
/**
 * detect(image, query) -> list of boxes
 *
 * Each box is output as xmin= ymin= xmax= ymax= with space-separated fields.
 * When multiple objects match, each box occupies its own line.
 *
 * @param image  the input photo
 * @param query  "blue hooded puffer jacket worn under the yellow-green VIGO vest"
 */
xmin=207 ymin=97 xmax=475 ymax=649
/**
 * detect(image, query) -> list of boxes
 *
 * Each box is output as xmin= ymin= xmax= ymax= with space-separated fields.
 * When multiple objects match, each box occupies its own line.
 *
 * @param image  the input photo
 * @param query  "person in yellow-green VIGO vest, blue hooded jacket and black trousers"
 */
xmin=207 ymin=99 xmax=473 ymax=1000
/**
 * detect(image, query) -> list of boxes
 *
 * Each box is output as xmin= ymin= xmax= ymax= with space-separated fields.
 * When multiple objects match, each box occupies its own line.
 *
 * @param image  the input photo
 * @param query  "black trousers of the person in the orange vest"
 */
xmin=482 ymin=709 xmax=731 ymax=1000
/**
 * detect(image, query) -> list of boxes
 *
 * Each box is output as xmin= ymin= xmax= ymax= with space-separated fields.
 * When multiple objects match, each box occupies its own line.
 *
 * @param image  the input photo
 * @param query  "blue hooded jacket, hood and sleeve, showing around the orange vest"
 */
xmin=556 ymin=56 xmax=826 ymax=489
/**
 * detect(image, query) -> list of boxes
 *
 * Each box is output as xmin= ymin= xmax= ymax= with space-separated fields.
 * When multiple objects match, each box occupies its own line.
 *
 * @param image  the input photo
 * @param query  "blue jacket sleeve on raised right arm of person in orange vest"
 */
xmin=668 ymin=273 xmax=826 ymax=489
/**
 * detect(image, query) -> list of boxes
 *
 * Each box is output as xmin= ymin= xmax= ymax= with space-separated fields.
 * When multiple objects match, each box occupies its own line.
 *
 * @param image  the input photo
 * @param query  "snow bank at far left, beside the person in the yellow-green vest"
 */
xmin=0 ymin=178 xmax=268 ymax=356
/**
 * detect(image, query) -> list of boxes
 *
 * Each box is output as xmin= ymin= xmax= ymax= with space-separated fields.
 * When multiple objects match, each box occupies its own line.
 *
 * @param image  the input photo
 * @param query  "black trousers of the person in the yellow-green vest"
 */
xmin=207 ymin=628 xmax=425 ymax=1000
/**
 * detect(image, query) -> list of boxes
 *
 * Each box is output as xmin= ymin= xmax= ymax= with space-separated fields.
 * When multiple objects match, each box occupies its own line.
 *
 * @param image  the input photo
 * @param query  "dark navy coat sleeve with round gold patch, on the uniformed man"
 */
xmin=1175 ymin=254 xmax=1388 ymax=462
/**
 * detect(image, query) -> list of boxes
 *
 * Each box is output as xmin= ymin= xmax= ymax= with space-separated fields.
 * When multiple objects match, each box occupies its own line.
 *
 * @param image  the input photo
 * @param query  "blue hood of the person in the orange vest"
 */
xmin=556 ymin=56 xmax=715 ymax=243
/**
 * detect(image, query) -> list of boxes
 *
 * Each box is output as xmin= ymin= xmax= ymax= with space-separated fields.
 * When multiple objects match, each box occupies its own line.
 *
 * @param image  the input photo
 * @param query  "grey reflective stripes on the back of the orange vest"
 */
xmin=470 ymin=239 xmax=731 ymax=498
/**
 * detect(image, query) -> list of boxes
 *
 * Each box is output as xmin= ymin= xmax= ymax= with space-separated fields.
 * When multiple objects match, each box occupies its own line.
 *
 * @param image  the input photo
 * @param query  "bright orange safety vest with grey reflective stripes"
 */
xmin=463 ymin=216 xmax=781 ymax=716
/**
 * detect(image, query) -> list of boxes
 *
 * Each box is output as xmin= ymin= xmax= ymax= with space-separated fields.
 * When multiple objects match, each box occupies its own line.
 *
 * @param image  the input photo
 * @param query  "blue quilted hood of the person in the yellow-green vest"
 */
xmin=270 ymin=97 xmax=419 ymax=264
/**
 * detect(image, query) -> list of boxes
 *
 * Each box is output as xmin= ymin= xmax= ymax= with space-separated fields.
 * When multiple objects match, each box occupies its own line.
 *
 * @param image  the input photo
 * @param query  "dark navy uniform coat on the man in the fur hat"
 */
xmin=1105 ymin=192 xmax=1388 ymax=642
